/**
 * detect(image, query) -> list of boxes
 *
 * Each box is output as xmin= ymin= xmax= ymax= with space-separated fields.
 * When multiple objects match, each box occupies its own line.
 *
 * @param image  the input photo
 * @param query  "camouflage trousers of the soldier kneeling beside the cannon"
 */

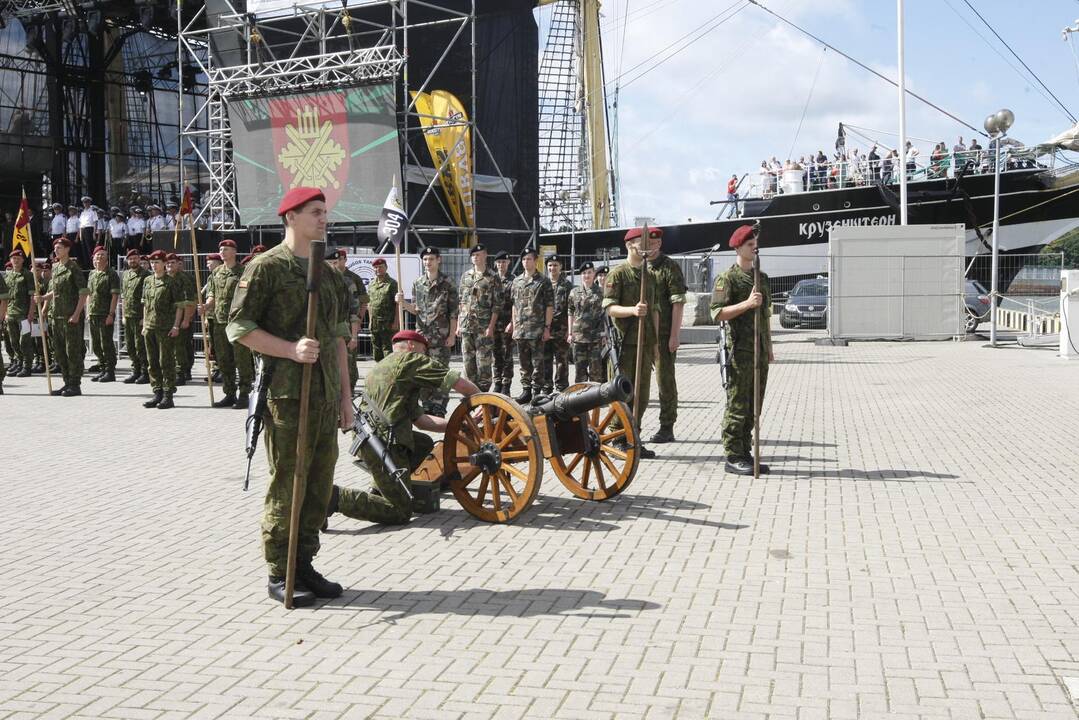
xmin=338 ymin=433 xmax=435 ymax=525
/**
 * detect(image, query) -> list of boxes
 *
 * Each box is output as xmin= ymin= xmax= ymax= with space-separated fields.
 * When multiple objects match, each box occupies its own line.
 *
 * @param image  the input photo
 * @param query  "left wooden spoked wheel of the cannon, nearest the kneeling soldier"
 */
xmin=442 ymin=393 xmax=543 ymax=522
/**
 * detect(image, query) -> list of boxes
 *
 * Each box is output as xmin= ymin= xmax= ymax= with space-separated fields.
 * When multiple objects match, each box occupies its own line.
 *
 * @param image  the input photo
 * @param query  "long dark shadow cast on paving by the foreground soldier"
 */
xmin=323 ymin=587 xmax=661 ymax=623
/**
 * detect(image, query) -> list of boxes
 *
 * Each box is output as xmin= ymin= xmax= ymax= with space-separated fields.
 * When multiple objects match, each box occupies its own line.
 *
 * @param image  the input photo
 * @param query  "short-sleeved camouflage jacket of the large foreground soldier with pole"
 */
xmin=226 ymin=243 xmax=351 ymax=408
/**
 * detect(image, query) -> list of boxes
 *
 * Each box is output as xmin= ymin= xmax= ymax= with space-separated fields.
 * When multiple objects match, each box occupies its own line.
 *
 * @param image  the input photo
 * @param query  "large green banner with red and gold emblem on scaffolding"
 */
xmin=229 ymin=84 xmax=400 ymax=226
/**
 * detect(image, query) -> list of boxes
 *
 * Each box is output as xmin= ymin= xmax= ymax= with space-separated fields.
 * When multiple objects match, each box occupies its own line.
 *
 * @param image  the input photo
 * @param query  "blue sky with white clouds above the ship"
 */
xmin=536 ymin=0 xmax=1079 ymax=222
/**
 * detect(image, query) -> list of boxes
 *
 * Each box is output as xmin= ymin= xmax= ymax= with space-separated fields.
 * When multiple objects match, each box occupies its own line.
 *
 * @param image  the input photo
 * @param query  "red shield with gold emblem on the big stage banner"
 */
xmin=270 ymin=93 xmax=349 ymax=209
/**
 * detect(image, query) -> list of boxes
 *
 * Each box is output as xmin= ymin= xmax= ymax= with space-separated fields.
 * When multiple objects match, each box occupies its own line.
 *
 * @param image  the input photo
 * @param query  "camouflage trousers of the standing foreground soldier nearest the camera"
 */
xmin=262 ymin=399 xmax=341 ymax=578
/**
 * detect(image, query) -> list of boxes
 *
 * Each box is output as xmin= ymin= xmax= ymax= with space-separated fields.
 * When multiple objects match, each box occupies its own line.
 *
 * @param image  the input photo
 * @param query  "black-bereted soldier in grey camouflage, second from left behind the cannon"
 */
xmin=457 ymin=243 xmax=502 ymax=393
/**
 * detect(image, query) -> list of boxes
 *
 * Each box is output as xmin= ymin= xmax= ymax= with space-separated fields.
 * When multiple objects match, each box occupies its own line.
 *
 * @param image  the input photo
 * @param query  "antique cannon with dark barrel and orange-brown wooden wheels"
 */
xmin=412 ymin=376 xmax=640 ymax=522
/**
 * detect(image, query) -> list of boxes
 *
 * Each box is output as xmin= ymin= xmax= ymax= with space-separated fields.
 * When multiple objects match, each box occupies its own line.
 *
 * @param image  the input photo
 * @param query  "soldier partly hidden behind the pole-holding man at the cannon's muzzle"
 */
xmin=648 ymin=235 xmax=686 ymax=443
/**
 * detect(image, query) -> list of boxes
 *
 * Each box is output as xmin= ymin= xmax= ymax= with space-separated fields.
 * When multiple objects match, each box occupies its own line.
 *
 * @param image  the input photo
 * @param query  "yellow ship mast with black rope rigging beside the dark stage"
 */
xmin=540 ymin=0 xmax=615 ymax=230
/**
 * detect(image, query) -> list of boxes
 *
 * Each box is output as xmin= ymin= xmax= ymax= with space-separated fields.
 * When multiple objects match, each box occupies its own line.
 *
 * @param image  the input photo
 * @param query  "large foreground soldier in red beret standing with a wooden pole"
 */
xmin=228 ymin=187 xmax=353 ymax=608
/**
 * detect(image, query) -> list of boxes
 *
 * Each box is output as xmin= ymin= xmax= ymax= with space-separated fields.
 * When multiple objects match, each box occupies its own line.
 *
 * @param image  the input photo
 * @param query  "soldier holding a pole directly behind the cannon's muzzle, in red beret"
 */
xmin=603 ymin=228 xmax=663 ymax=459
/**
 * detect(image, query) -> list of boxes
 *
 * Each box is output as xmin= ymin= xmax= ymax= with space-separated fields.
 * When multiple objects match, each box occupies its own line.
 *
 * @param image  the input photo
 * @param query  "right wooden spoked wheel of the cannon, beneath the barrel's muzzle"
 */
xmin=550 ymin=382 xmax=641 ymax=500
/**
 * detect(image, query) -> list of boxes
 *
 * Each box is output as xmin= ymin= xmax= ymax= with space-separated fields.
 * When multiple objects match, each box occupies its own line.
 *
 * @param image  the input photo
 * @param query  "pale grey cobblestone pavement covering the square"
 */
xmin=0 ymin=332 xmax=1079 ymax=720
